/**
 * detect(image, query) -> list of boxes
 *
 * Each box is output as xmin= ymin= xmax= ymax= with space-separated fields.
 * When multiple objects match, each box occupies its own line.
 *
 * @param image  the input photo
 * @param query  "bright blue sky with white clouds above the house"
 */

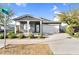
xmin=0 ymin=3 xmax=79 ymax=20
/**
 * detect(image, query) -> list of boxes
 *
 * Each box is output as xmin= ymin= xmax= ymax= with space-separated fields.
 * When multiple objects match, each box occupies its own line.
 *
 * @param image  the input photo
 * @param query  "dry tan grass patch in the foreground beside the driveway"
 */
xmin=0 ymin=44 xmax=53 ymax=55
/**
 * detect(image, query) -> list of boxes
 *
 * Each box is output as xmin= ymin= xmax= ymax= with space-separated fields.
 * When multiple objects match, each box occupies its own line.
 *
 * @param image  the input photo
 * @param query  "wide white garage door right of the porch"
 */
xmin=43 ymin=24 xmax=59 ymax=34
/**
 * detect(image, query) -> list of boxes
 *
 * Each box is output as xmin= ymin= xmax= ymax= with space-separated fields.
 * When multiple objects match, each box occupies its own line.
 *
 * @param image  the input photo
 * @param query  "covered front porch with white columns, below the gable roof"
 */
xmin=15 ymin=20 xmax=43 ymax=34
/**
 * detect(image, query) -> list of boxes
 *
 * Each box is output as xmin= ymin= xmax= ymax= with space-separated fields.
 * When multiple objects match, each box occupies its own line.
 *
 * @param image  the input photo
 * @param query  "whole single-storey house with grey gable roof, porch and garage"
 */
xmin=13 ymin=14 xmax=61 ymax=34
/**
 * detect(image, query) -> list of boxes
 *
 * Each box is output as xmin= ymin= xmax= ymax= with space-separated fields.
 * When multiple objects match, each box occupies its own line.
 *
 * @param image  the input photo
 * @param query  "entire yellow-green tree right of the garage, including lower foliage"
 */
xmin=58 ymin=9 xmax=79 ymax=35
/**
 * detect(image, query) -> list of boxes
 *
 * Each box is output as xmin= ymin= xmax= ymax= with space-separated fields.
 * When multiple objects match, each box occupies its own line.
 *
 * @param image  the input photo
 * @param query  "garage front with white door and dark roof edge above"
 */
xmin=43 ymin=22 xmax=61 ymax=34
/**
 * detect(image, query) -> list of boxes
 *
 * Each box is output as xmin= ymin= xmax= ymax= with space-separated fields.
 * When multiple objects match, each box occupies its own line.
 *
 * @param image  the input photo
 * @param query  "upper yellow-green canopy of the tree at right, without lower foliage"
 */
xmin=58 ymin=9 xmax=79 ymax=25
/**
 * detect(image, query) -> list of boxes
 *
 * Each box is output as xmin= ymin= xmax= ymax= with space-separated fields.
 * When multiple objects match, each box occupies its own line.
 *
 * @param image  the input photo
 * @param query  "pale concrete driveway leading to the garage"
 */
xmin=47 ymin=33 xmax=79 ymax=55
